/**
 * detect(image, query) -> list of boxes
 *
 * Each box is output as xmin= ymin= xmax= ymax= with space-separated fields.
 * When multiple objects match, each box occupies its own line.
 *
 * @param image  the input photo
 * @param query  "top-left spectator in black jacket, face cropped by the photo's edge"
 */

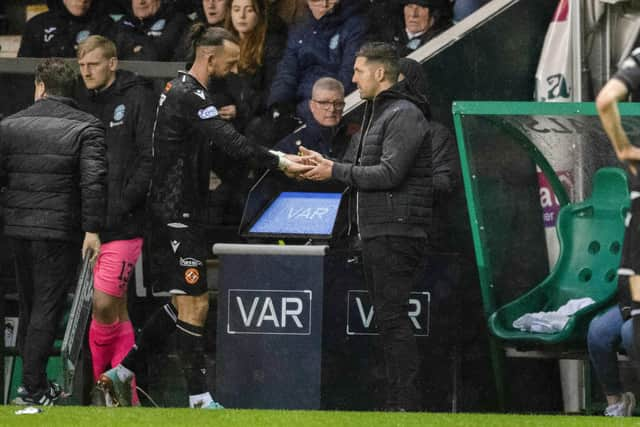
xmin=18 ymin=0 xmax=113 ymax=58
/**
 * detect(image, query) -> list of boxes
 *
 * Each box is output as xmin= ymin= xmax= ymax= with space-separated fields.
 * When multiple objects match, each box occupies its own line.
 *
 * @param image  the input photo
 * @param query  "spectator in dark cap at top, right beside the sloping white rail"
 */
xmin=376 ymin=0 xmax=452 ymax=56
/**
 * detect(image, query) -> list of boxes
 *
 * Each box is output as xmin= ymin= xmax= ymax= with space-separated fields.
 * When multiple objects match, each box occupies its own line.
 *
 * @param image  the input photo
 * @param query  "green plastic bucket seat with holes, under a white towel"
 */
xmin=489 ymin=168 xmax=630 ymax=344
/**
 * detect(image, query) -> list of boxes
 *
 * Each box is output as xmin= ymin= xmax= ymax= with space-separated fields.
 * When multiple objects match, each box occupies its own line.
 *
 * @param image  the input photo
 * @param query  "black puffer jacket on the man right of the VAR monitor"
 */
xmin=332 ymin=82 xmax=433 ymax=239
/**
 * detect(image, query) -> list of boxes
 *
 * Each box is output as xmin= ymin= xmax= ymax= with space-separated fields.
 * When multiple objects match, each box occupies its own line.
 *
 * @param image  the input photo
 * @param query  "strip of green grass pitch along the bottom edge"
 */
xmin=0 ymin=406 xmax=640 ymax=427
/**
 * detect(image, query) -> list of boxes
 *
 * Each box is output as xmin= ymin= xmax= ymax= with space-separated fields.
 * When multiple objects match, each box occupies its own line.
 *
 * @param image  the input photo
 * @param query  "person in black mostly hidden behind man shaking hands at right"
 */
xmin=399 ymin=58 xmax=460 ymax=252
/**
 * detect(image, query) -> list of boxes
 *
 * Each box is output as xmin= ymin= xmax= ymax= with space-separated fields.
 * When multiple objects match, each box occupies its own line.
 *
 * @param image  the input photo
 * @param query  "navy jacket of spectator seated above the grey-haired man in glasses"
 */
xmin=267 ymin=0 xmax=367 ymax=122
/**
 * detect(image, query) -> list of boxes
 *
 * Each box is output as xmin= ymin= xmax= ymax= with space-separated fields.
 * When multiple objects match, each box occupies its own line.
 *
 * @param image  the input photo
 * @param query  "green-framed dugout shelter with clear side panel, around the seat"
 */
xmin=453 ymin=102 xmax=640 ymax=411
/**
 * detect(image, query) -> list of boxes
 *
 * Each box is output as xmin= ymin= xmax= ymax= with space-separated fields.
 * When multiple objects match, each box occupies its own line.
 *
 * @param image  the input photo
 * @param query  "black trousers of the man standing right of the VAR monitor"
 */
xmin=362 ymin=236 xmax=426 ymax=410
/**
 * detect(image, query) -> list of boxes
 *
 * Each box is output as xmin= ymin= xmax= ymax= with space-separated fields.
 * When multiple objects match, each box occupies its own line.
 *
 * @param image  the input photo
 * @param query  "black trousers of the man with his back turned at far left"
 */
xmin=11 ymin=238 xmax=80 ymax=392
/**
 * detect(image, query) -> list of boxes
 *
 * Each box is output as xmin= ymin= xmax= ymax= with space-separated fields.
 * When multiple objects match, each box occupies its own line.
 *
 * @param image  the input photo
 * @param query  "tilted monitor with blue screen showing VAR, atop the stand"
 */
xmin=248 ymin=191 xmax=342 ymax=239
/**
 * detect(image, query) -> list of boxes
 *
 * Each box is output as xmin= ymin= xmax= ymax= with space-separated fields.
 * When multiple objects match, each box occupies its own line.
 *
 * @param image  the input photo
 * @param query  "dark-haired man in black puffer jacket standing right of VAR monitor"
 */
xmin=302 ymin=43 xmax=433 ymax=410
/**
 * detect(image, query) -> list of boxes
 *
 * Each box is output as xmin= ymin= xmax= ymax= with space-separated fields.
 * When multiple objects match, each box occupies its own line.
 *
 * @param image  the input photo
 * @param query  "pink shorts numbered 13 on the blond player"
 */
xmin=93 ymin=237 xmax=142 ymax=298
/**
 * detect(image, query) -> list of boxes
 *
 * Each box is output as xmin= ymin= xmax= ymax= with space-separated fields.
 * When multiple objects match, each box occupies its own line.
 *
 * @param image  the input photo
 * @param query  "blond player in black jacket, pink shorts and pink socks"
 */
xmin=78 ymin=36 xmax=157 ymax=401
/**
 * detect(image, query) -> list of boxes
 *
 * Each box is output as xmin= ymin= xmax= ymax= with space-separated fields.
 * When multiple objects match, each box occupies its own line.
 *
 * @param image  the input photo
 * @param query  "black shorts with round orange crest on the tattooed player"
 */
xmin=149 ymin=222 xmax=208 ymax=296
